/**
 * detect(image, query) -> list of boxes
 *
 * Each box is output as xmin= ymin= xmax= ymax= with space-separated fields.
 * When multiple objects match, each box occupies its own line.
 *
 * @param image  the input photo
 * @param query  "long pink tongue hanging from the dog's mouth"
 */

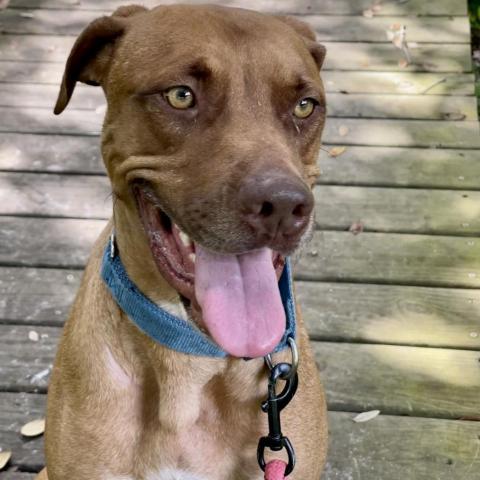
xmin=195 ymin=245 xmax=286 ymax=358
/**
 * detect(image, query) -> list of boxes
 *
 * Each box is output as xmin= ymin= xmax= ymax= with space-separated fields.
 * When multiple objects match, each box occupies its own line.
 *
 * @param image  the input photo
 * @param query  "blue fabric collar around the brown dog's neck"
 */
xmin=101 ymin=235 xmax=296 ymax=358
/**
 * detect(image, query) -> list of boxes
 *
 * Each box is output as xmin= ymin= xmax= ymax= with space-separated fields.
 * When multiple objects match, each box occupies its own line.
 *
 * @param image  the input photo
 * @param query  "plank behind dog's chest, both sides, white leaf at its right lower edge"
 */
xmin=0 ymin=325 xmax=480 ymax=418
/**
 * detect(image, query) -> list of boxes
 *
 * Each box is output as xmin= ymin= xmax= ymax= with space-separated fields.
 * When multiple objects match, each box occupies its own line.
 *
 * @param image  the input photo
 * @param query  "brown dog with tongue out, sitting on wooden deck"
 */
xmin=39 ymin=5 xmax=327 ymax=480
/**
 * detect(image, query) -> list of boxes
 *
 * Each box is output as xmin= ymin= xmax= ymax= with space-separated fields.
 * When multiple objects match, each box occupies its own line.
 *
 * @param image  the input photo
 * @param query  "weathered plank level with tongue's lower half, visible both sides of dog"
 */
xmin=0 ymin=267 xmax=480 ymax=349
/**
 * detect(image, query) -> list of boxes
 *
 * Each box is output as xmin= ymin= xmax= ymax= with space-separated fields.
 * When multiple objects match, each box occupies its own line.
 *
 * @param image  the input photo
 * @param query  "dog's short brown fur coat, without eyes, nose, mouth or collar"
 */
xmin=37 ymin=6 xmax=327 ymax=480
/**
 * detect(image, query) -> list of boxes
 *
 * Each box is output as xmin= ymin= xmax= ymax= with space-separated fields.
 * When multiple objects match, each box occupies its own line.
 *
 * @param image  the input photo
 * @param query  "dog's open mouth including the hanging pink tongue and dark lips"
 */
xmin=134 ymin=185 xmax=286 ymax=358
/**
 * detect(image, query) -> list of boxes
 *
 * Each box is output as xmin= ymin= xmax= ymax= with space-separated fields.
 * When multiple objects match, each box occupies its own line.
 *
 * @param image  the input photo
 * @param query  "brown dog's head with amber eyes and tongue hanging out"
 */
xmin=55 ymin=5 xmax=325 ymax=356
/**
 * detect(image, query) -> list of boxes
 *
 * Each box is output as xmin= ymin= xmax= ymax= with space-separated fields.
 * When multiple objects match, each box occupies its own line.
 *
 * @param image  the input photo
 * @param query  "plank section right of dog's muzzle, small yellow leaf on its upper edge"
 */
xmin=320 ymin=146 xmax=480 ymax=189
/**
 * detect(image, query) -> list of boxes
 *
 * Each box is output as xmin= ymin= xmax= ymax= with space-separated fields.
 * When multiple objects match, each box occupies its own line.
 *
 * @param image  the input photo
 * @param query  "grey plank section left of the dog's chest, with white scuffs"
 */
xmin=0 ymin=325 xmax=61 ymax=393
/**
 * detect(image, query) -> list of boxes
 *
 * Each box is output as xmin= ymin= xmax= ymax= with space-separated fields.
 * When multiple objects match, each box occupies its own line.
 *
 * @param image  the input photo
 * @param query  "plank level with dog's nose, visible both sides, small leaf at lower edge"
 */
xmin=0 ymin=173 xmax=480 ymax=235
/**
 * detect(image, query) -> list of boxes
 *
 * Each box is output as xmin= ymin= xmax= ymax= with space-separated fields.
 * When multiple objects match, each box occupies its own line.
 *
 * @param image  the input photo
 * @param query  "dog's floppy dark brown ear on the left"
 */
xmin=53 ymin=5 xmax=146 ymax=115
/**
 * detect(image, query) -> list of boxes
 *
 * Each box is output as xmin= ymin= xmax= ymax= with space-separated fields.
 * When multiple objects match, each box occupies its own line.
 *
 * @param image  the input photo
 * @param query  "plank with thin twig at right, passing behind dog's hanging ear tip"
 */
xmin=0 ymin=61 xmax=475 ymax=98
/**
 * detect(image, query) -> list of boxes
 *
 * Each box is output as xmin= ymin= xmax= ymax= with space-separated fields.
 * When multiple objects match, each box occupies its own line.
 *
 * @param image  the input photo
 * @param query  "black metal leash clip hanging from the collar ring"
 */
xmin=257 ymin=337 xmax=298 ymax=476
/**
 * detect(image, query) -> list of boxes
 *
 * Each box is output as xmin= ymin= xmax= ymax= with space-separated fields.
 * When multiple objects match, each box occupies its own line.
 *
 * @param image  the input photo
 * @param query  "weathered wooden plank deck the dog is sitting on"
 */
xmin=0 ymin=0 xmax=480 ymax=480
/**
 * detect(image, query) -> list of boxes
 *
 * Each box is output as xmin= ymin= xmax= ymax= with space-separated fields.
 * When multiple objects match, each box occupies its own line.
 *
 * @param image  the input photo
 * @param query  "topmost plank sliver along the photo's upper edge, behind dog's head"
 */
xmin=5 ymin=0 xmax=467 ymax=16
